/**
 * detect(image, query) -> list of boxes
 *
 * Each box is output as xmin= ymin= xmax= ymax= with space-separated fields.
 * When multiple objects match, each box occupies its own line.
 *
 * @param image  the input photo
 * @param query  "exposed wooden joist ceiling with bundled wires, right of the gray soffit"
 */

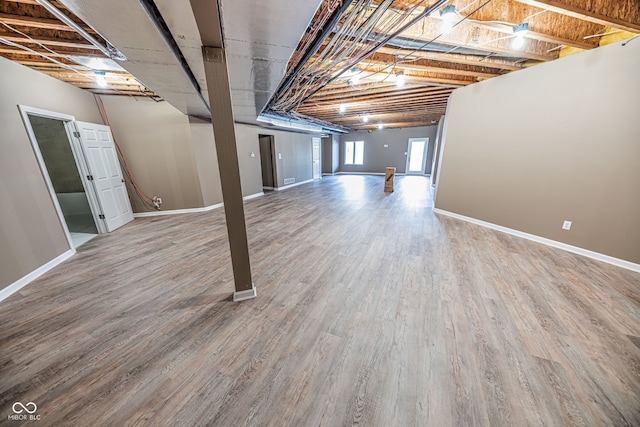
xmin=266 ymin=0 xmax=640 ymax=129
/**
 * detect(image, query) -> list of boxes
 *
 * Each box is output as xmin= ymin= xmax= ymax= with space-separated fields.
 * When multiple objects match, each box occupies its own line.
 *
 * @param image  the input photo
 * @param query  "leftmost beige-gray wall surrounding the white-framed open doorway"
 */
xmin=0 ymin=58 xmax=102 ymax=289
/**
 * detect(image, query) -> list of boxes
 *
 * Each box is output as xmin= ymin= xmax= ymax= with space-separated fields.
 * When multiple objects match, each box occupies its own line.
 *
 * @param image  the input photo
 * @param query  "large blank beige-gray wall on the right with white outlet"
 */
xmin=435 ymin=42 xmax=640 ymax=264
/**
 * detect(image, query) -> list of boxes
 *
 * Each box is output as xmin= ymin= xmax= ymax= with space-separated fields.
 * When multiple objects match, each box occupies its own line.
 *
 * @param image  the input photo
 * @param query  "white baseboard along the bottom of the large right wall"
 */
xmin=433 ymin=208 xmax=640 ymax=273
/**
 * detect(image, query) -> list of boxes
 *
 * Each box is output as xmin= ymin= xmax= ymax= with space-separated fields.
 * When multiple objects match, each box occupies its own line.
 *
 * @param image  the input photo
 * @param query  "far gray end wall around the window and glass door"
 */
xmin=339 ymin=126 xmax=437 ymax=174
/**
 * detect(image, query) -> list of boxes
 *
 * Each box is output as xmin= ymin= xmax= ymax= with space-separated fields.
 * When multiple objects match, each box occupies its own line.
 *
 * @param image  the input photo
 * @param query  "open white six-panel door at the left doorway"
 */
xmin=76 ymin=122 xmax=133 ymax=232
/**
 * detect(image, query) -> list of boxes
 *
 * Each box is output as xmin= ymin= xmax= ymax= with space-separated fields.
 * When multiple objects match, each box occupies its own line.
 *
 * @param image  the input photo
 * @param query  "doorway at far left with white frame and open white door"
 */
xmin=19 ymin=106 xmax=133 ymax=249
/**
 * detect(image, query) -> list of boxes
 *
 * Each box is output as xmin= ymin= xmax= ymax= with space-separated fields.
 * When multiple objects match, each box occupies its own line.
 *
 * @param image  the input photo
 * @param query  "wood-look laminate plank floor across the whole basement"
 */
xmin=0 ymin=176 xmax=640 ymax=427
